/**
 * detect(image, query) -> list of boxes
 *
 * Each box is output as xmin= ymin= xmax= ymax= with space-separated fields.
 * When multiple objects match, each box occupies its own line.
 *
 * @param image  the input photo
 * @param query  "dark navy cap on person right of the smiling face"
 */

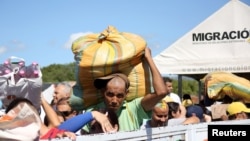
xmin=186 ymin=105 xmax=204 ymax=121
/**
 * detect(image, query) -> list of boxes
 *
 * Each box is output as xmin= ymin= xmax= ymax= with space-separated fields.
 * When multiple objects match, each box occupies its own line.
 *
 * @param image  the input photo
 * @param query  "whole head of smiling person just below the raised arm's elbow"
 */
xmin=151 ymin=101 xmax=169 ymax=127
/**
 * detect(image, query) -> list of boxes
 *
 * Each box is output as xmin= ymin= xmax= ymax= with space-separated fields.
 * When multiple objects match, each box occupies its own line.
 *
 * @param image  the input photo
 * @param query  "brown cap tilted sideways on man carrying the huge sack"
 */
xmin=94 ymin=73 xmax=130 ymax=89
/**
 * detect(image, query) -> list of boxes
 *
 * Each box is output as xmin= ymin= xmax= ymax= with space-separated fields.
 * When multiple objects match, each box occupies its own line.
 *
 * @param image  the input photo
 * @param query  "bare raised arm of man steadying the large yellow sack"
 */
xmin=141 ymin=48 xmax=167 ymax=111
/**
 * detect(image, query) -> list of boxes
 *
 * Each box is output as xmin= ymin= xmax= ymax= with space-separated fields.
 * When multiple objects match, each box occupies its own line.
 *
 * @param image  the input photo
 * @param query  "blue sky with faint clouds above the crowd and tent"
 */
xmin=0 ymin=0 xmax=250 ymax=67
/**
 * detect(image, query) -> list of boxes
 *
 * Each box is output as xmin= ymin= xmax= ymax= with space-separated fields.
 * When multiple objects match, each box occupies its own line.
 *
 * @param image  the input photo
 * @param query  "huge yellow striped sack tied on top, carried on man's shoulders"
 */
xmin=70 ymin=26 xmax=151 ymax=109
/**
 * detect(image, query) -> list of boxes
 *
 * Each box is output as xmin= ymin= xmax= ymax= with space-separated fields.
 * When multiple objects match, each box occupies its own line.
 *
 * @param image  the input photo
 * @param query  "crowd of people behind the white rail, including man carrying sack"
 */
xmin=0 ymin=48 xmax=250 ymax=140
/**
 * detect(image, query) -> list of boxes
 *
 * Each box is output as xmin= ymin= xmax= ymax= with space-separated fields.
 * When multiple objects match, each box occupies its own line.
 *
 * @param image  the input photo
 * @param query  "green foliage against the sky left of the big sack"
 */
xmin=41 ymin=63 xmax=76 ymax=83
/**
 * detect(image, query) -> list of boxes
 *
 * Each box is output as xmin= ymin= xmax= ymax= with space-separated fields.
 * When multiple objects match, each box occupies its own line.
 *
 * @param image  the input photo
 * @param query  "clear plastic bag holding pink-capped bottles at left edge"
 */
xmin=0 ymin=56 xmax=42 ymax=111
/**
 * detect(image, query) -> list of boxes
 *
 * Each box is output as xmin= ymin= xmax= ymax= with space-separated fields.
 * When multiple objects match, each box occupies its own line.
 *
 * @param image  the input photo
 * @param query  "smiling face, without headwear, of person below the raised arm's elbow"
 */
xmin=151 ymin=107 xmax=168 ymax=127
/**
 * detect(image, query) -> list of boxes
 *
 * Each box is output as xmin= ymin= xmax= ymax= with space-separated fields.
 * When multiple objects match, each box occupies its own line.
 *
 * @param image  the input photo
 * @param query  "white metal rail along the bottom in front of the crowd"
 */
xmin=44 ymin=119 xmax=250 ymax=141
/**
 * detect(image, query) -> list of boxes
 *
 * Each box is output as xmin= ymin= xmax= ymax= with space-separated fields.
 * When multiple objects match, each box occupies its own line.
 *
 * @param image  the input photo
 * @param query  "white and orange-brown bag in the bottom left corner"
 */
xmin=0 ymin=103 xmax=41 ymax=141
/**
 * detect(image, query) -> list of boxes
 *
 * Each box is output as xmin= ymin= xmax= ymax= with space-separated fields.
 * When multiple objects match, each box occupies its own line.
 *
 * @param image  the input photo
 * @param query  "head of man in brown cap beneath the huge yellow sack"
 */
xmin=94 ymin=73 xmax=130 ymax=111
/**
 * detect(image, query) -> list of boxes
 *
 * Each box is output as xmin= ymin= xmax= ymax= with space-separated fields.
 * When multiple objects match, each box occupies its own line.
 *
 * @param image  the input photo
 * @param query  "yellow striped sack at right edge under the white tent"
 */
xmin=202 ymin=72 xmax=250 ymax=103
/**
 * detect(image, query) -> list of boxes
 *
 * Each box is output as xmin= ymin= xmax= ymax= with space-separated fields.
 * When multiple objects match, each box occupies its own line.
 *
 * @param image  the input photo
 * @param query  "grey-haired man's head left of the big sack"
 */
xmin=53 ymin=82 xmax=72 ymax=104
